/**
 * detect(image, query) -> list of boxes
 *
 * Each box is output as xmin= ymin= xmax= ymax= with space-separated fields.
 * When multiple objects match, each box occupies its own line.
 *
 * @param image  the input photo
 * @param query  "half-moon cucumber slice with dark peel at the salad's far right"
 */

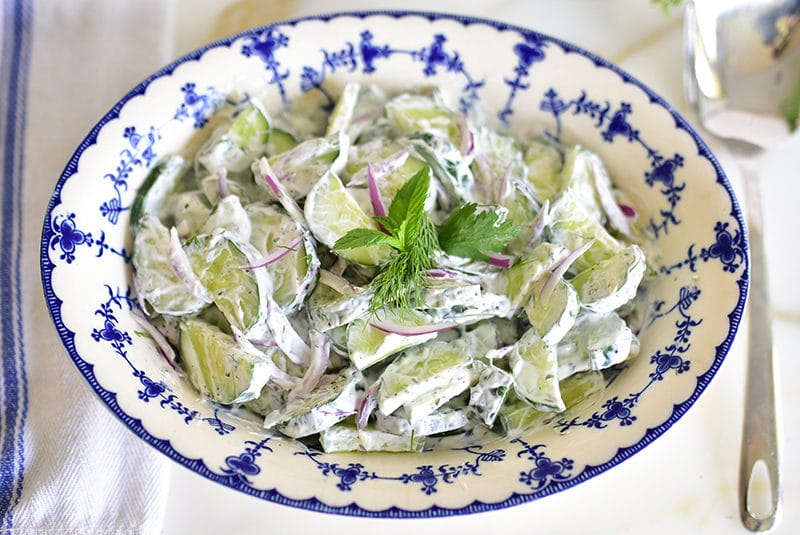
xmin=571 ymin=244 xmax=647 ymax=313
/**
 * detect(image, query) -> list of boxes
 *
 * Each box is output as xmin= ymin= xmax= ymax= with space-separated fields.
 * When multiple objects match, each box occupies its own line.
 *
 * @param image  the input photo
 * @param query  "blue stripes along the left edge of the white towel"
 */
xmin=0 ymin=0 xmax=32 ymax=532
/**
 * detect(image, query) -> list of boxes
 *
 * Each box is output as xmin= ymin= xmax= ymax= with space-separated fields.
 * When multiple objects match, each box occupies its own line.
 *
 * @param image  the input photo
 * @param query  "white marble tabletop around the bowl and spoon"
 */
xmin=158 ymin=0 xmax=800 ymax=535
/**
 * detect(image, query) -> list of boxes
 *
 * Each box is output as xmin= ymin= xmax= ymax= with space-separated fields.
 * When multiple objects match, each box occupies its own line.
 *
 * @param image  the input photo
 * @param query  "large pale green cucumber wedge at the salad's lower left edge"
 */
xmin=179 ymin=318 xmax=269 ymax=404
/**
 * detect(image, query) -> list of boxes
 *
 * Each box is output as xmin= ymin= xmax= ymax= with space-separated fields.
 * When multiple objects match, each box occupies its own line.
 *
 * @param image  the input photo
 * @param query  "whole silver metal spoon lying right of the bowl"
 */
xmin=684 ymin=0 xmax=800 ymax=531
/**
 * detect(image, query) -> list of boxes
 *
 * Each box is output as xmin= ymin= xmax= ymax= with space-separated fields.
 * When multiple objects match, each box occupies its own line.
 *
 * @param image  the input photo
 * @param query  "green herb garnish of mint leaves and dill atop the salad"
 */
xmin=333 ymin=165 xmax=519 ymax=315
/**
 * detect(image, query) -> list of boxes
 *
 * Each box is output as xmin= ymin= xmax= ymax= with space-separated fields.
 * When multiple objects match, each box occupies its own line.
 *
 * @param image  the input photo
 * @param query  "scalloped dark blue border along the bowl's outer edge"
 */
xmin=40 ymin=9 xmax=750 ymax=518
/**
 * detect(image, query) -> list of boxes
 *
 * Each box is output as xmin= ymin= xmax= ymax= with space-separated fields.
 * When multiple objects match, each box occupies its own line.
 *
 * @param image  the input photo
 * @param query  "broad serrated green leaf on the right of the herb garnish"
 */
xmin=439 ymin=203 xmax=519 ymax=260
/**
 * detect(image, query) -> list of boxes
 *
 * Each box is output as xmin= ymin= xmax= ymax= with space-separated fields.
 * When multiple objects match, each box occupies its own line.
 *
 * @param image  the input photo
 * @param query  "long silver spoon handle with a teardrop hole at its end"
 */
xmin=739 ymin=158 xmax=783 ymax=531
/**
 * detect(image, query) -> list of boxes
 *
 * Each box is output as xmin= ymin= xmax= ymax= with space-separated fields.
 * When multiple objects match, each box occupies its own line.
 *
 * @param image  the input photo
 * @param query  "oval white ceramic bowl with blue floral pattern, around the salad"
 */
xmin=41 ymin=13 xmax=748 ymax=517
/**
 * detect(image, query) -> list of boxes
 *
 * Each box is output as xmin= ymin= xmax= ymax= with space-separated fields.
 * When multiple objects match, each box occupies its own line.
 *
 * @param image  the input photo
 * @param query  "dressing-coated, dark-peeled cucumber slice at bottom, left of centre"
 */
xmin=264 ymin=368 xmax=364 ymax=438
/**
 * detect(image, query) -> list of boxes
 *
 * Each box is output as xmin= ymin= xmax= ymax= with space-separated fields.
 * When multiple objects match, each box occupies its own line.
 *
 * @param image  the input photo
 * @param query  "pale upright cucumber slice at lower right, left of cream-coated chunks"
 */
xmin=508 ymin=329 xmax=566 ymax=412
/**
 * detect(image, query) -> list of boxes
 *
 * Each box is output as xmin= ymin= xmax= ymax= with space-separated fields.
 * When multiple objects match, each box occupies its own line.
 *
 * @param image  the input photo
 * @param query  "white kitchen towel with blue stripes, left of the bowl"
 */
xmin=0 ymin=0 xmax=172 ymax=534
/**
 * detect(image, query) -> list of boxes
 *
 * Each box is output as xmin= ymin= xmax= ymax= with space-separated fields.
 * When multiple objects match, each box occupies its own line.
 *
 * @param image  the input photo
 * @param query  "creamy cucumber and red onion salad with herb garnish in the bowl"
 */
xmin=131 ymin=84 xmax=651 ymax=452
